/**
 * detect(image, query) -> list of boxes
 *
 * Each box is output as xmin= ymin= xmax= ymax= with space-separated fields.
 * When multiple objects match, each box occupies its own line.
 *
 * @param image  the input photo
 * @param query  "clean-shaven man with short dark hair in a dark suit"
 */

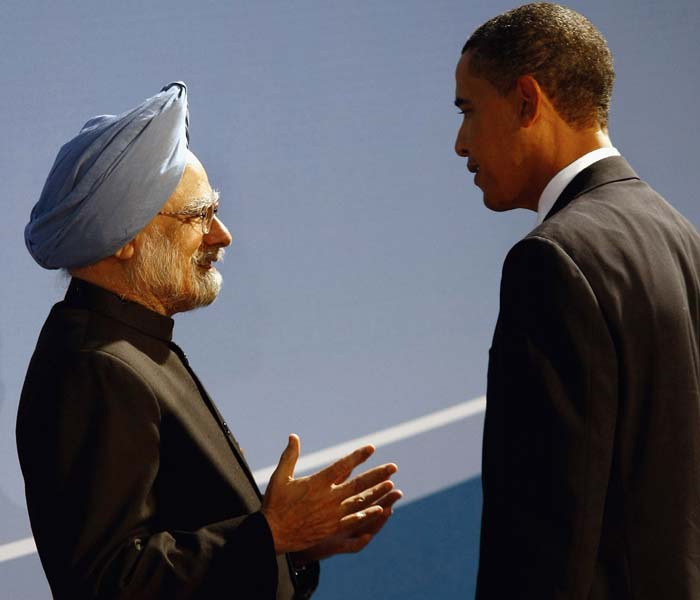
xmin=455 ymin=4 xmax=700 ymax=600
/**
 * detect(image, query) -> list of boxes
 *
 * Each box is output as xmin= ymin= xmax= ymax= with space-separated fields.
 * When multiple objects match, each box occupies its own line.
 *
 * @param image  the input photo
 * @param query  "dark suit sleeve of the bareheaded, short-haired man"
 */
xmin=477 ymin=237 xmax=618 ymax=600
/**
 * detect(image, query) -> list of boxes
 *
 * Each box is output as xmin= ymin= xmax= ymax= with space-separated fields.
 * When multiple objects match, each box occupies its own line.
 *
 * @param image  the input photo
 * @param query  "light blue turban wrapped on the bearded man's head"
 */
xmin=24 ymin=82 xmax=189 ymax=269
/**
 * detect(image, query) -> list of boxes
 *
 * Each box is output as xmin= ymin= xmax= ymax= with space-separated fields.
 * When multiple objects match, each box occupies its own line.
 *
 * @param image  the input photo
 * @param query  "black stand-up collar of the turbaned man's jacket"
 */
xmin=65 ymin=277 xmax=174 ymax=342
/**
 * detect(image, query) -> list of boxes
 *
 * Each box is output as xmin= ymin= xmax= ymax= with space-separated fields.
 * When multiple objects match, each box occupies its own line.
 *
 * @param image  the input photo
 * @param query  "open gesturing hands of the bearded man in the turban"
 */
xmin=263 ymin=434 xmax=400 ymax=554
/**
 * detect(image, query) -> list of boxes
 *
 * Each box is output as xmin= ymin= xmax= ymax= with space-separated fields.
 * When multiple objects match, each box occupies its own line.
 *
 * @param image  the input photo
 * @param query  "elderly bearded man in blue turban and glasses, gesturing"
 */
xmin=17 ymin=83 xmax=401 ymax=600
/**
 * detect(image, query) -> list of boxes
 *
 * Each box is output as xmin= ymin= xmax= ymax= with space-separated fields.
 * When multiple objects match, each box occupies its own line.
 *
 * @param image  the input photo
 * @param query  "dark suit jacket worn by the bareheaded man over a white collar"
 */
xmin=477 ymin=157 xmax=700 ymax=600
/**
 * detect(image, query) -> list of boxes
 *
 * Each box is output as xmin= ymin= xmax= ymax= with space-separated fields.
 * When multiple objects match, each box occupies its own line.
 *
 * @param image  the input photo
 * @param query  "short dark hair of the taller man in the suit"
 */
xmin=462 ymin=2 xmax=615 ymax=128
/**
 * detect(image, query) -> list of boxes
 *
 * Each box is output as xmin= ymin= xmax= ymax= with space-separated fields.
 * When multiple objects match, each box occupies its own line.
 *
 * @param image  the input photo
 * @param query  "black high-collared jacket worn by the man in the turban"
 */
xmin=17 ymin=280 xmax=318 ymax=600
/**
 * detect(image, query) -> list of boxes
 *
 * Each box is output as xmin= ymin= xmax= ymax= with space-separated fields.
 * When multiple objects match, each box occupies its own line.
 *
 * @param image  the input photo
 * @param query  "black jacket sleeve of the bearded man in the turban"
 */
xmin=18 ymin=351 xmax=277 ymax=600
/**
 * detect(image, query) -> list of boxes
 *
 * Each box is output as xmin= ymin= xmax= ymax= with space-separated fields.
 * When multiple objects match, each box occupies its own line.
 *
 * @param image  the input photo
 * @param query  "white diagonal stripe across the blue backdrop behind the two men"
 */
xmin=0 ymin=396 xmax=486 ymax=563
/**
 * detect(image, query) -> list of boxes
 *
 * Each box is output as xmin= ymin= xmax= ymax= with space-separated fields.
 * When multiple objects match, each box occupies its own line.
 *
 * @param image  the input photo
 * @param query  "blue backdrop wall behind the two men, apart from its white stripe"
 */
xmin=0 ymin=0 xmax=700 ymax=600
